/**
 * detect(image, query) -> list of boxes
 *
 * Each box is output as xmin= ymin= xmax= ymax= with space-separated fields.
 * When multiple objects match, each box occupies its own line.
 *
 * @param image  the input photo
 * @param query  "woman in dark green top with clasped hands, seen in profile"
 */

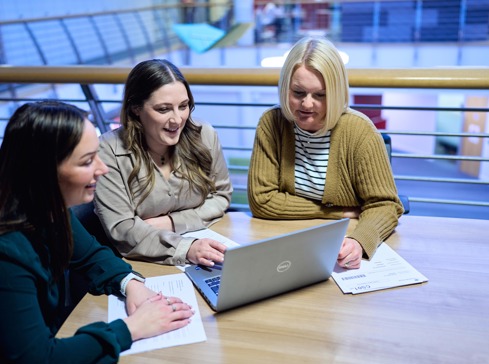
xmin=0 ymin=101 xmax=193 ymax=363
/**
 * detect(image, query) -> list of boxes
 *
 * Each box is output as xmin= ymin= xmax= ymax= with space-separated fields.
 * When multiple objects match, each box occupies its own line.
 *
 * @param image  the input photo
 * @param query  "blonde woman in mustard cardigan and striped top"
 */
xmin=248 ymin=37 xmax=403 ymax=268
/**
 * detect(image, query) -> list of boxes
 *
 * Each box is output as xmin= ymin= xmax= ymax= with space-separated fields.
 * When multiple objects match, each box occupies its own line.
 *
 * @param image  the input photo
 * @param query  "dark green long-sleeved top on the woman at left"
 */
xmin=0 ymin=215 xmax=132 ymax=364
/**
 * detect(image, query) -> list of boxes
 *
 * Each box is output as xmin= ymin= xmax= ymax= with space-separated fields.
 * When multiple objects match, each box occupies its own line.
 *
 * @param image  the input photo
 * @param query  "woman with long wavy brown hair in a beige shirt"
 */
xmin=95 ymin=59 xmax=232 ymax=266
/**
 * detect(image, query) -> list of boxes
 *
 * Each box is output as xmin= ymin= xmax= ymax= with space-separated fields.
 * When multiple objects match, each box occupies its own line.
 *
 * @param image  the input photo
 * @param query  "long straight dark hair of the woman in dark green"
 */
xmin=0 ymin=101 xmax=86 ymax=279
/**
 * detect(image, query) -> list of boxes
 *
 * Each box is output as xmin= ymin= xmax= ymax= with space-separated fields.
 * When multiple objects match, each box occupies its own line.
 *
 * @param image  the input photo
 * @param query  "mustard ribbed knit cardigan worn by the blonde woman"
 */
xmin=248 ymin=107 xmax=403 ymax=259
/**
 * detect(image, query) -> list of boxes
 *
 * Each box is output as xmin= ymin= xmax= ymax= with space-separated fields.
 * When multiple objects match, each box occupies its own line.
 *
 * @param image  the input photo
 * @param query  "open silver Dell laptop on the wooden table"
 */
xmin=185 ymin=218 xmax=349 ymax=312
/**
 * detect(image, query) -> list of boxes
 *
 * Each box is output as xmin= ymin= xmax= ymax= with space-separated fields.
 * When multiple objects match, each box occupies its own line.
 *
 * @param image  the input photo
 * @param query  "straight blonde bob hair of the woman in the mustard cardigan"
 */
xmin=278 ymin=37 xmax=350 ymax=134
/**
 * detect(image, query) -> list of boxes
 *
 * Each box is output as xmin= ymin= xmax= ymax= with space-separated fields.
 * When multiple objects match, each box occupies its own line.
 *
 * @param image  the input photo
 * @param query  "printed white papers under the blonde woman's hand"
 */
xmin=332 ymin=243 xmax=428 ymax=294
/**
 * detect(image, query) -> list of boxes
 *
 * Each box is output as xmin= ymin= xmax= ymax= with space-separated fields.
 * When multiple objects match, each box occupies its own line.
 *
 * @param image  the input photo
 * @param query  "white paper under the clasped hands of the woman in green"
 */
xmin=109 ymin=273 xmax=207 ymax=355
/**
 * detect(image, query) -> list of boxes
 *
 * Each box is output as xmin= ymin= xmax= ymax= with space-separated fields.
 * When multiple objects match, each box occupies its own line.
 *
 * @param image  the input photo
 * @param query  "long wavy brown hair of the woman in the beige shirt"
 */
xmin=121 ymin=59 xmax=216 ymax=204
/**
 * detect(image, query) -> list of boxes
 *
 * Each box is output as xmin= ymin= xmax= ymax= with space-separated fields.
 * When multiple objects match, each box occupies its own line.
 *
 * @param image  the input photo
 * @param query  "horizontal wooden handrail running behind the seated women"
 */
xmin=0 ymin=66 xmax=489 ymax=90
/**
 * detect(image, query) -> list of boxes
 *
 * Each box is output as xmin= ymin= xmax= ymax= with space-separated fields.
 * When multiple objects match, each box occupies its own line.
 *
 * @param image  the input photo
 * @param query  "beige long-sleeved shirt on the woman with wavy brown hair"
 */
xmin=95 ymin=124 xmax=233 ymax=265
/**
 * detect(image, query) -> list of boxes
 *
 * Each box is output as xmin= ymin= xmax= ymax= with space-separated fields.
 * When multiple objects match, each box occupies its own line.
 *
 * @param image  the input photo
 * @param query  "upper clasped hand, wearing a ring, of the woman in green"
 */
xmin=124 ymin=293 xmax=194 ymax=341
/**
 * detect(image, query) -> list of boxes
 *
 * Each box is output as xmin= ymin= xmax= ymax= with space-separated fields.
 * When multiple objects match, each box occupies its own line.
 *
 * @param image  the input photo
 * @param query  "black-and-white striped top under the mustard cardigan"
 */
xmin=294 ymin=125 xmax=331 ymax=201
